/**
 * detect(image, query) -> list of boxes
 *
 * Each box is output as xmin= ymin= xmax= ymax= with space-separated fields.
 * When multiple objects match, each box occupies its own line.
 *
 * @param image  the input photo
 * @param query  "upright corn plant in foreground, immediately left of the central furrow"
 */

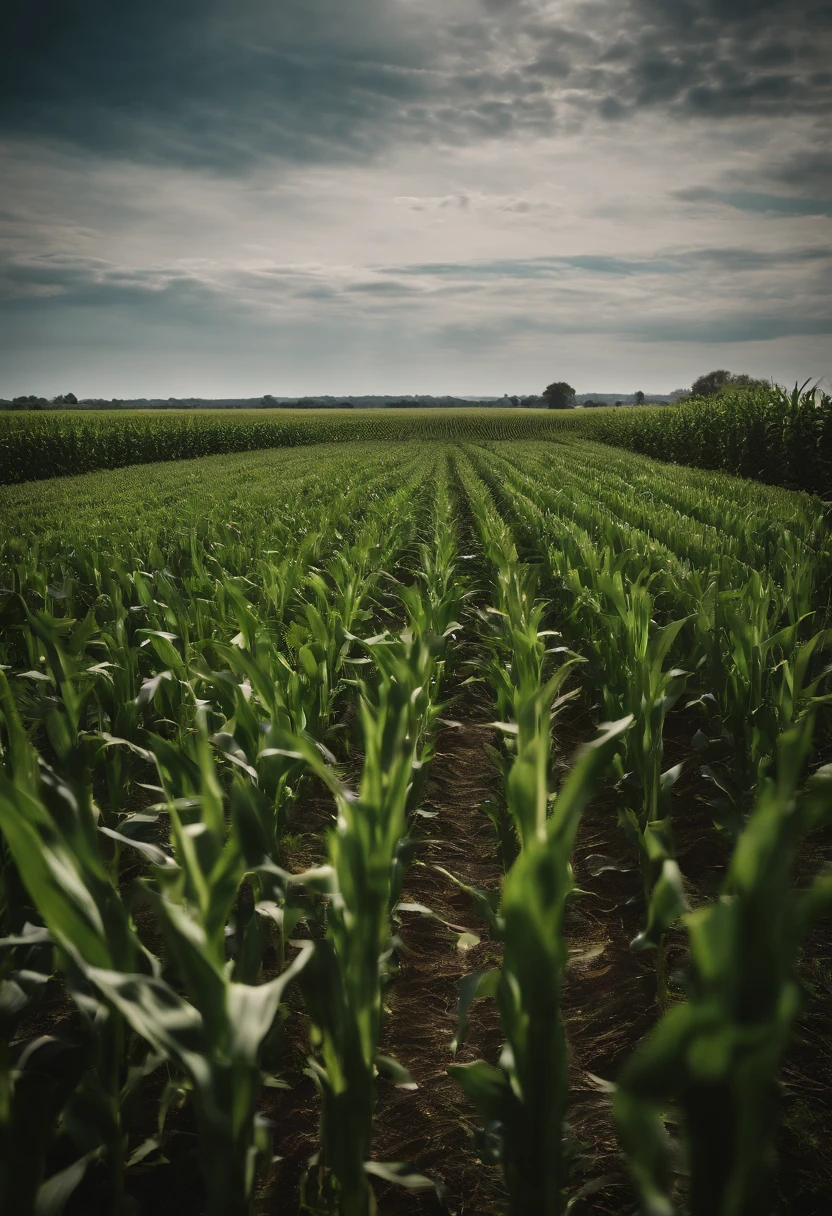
xmin=294 ymin=617 xmax=440 ymax=1216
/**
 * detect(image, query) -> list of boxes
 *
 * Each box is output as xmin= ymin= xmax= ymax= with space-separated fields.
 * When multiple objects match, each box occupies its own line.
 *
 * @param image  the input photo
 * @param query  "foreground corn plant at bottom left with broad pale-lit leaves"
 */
xmin=0 ymin=676 xmax=307 ymax=1216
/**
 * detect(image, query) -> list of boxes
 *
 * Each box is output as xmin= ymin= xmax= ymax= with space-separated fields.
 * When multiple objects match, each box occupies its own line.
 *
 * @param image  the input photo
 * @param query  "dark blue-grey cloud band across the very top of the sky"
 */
xmin=0 ymin=0 xmax=832 ymax=170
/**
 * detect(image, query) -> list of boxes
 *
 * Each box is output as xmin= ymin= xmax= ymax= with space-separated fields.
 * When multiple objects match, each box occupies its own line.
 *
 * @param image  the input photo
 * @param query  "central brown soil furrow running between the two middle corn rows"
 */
xmin=373 ymin=688 xmax=502 ymax=1216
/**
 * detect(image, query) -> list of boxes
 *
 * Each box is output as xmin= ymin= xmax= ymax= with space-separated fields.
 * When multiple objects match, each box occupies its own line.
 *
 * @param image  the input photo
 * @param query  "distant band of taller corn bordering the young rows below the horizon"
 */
xmin=0 ymin=385 xmax=832 ymax=499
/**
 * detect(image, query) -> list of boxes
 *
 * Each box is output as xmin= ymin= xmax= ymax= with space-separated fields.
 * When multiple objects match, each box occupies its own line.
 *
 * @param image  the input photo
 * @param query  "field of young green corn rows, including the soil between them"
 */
xmin=0 ymin=435 xmax=832 ymax=1216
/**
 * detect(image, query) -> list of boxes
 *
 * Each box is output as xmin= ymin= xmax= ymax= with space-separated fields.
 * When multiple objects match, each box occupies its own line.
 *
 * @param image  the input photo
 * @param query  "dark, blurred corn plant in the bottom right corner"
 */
xmin=614 ymin=715 xmax=832 ymax=1216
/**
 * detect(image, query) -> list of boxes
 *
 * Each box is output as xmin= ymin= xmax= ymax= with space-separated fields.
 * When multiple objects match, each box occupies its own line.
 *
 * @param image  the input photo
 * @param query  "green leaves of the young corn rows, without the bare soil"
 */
xmin=0 ymin=437 xmax=832 ymax=1216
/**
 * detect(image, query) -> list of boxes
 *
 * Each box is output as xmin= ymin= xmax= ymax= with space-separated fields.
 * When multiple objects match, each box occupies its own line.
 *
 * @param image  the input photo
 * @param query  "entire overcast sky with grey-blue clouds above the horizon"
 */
xmin=0 ymin=0 xmax=832 ymax=398
